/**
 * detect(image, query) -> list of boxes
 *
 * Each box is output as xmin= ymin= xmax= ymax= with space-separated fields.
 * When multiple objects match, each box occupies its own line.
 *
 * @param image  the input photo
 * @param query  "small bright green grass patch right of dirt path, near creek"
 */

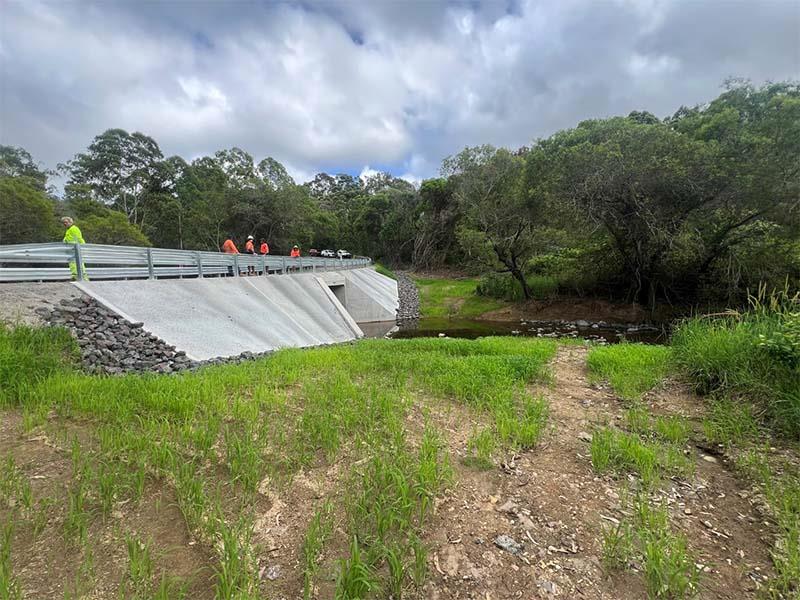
xmin=587 ymin=344 xmax=671 ymax=400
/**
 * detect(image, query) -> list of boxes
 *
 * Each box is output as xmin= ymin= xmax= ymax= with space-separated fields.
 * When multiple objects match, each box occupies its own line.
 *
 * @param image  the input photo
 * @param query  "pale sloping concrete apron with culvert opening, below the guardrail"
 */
xmin=75 ymin=269 xmax=398 ymax=360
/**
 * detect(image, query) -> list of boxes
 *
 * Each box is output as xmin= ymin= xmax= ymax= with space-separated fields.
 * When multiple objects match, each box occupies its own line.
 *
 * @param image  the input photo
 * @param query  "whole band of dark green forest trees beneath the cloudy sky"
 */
xmin=0 ymin=80 xmax=800 ymax=308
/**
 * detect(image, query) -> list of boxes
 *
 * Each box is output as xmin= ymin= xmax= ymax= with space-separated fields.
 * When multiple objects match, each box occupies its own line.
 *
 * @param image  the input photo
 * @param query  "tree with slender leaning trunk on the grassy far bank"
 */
xmin=442 ymin=146 xmax=534 ymax=300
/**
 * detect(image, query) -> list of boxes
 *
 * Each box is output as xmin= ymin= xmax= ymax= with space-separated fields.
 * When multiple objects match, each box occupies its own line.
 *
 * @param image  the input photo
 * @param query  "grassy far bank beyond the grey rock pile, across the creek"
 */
xmin=414 ymin=278 xmax=506 ymax=319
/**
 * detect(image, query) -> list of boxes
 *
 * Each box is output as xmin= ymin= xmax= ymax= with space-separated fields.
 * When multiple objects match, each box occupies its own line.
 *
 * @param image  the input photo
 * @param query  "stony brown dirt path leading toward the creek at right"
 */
xmin=425 ymin=346 xmax=770 ymax=600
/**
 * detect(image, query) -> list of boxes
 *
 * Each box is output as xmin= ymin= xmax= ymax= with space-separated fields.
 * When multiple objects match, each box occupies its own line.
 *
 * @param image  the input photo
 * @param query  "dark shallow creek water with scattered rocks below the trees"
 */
xmin=388 ymin=318 xmax=668 ymax=344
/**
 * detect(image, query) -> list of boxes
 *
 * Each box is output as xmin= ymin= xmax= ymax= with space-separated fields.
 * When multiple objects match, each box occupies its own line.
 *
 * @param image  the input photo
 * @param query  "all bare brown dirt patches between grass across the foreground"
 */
xmin=0 ymin=346 xmax=774 ymax=600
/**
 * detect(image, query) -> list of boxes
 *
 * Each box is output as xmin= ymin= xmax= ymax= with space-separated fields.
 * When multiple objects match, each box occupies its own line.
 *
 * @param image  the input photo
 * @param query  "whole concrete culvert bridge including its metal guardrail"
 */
xmin=0 ymin=243 xmax=398 ymax=360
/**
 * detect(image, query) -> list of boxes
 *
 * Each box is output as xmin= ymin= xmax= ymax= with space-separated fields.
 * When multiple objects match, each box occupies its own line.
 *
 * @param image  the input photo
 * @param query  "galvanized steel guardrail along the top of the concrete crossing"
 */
xmin=0 ymin=242 xmax=372 ymax=282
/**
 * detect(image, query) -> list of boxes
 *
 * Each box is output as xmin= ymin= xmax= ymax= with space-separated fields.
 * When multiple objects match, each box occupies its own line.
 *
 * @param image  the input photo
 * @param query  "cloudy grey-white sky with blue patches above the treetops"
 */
xmin=0 ymin=0 xmax=800 ymax=182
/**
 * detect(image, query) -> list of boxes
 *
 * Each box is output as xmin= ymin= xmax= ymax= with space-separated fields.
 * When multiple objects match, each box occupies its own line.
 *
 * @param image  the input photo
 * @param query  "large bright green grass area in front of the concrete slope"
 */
xmin=0 ymin=329 xmax=556 ymax=598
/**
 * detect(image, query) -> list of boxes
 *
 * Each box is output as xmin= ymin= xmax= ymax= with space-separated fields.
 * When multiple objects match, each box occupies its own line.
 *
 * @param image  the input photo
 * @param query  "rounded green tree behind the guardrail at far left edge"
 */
xmin=0 ymin=176 xmax=61 ymax=244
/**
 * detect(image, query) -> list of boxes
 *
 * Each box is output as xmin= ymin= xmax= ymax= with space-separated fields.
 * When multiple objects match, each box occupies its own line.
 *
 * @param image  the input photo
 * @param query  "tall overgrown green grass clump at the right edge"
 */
xmin=672 ymin=293 xmax=800 ymax=439
